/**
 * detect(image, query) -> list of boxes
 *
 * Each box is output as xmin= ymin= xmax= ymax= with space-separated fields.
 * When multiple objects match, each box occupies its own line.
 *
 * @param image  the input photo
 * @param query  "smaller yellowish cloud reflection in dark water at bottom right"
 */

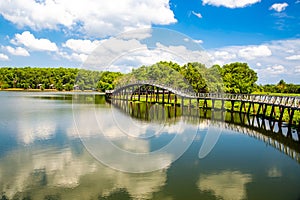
xmin=198 ymin=171 xmax=252 ymax=200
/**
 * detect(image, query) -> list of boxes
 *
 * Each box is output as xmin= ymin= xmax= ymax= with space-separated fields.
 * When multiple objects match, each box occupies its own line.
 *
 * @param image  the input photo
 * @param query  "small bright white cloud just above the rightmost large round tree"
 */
xmin=239 ymin=45 xmax=272 ymax=60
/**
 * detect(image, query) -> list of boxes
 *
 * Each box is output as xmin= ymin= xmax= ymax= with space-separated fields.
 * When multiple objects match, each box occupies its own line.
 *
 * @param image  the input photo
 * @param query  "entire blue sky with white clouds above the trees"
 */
xmin=0 ymin=0 xmax=300 ymax=84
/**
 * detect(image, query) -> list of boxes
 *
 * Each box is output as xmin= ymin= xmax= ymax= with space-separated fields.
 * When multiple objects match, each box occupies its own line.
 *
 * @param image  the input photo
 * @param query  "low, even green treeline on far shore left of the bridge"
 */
xmin=0 ymin=67 xmax=121 ymax=91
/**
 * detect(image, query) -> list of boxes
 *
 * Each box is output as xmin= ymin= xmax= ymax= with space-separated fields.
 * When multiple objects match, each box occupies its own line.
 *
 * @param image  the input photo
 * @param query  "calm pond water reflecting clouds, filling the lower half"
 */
xmin=0 ymin=92 xmax=300 ymax=200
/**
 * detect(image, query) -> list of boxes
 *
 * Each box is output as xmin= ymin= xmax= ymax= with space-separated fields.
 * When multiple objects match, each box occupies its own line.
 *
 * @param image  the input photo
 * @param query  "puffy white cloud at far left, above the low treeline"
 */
xmin=11 ymin=31 xmax=58 ymax=51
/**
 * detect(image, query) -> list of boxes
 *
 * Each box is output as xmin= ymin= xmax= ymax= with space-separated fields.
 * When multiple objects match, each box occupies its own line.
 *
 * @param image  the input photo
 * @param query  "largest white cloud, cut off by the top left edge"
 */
xmin=0 ymin=0 xmax=176 ymax=37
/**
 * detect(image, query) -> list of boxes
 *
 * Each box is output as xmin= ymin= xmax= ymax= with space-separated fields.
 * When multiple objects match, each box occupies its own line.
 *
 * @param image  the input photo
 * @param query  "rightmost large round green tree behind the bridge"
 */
xmin=222 ymin=62 xmax=258 ymax=94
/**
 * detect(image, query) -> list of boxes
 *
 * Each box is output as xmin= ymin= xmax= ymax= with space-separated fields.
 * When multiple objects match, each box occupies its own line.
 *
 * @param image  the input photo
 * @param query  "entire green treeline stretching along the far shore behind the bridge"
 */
xmin=0 ymin=61 xmax=300 ymax=93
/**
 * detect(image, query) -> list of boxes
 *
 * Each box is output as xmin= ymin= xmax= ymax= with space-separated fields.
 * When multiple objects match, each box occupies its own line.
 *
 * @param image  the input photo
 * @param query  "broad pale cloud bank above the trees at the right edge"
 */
xmin=208 ymin=39 xmax=300 ymax=83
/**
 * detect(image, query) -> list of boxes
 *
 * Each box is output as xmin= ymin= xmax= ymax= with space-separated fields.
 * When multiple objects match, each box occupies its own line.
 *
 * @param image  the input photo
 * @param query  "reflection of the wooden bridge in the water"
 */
xmin=111 ymin=99 xmax=300 ymax=163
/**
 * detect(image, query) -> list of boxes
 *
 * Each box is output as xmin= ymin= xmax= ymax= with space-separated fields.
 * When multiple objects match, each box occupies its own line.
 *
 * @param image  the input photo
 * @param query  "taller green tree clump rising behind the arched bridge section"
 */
xmin=119 ymin=61 xmax=257 ymax=93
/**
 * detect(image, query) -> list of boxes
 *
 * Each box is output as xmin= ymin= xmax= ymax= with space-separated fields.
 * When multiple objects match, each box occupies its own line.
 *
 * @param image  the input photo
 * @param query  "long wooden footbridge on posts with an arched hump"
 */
xmin=106 ymin=81 xmax=300 ymax=128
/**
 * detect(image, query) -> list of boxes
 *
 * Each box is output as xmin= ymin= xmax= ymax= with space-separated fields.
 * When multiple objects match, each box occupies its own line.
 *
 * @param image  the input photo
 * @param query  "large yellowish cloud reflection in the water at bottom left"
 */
xmin=0 ymin=145 xmax=166 ymax=199
